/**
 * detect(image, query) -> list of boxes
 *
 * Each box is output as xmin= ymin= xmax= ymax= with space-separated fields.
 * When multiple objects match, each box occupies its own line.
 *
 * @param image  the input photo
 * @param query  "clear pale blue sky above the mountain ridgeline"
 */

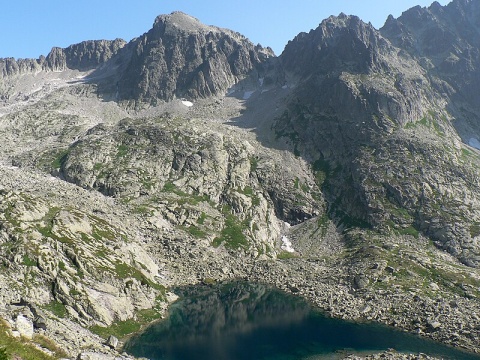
xmin=0 ymin=0 xmax=450 ymax=58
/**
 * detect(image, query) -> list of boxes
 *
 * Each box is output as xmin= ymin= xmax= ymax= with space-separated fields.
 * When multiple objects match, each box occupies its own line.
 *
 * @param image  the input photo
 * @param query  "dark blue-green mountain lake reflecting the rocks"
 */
xmin=125 ymin=282 xmax=480 ymax=360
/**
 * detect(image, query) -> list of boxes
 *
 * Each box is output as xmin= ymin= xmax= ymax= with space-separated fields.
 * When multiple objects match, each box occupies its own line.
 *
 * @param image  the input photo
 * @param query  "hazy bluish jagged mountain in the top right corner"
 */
xmin=380 ymin=0 xmax=480 ymax=136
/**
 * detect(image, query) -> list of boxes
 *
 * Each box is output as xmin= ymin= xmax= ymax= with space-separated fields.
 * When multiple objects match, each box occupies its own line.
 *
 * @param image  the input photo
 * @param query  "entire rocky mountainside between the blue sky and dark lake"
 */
xmin=0 ymin=0 xmax=480 ymax=358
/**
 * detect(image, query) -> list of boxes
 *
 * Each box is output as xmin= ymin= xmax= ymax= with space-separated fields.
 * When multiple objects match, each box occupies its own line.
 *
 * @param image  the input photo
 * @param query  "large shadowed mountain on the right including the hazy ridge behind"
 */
xmin=272 ymin=1 xmax=480 ymax=265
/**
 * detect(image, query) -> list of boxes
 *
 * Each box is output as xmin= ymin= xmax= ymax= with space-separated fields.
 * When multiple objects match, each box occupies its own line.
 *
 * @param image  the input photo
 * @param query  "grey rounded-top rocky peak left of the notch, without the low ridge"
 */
xmin=112 ymin=12 xmax=273 ymax=103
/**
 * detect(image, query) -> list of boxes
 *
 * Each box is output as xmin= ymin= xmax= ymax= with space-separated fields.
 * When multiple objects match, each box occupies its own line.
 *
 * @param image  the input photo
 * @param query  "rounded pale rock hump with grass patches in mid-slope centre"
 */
xmin=60 ymin=118 xmax=322 ymax=256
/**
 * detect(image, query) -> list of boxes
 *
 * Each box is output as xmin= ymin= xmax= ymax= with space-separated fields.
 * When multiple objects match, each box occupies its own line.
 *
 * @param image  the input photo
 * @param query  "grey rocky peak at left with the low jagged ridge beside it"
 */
xmin=0 ymin=12 xmax=274 ymax=104
